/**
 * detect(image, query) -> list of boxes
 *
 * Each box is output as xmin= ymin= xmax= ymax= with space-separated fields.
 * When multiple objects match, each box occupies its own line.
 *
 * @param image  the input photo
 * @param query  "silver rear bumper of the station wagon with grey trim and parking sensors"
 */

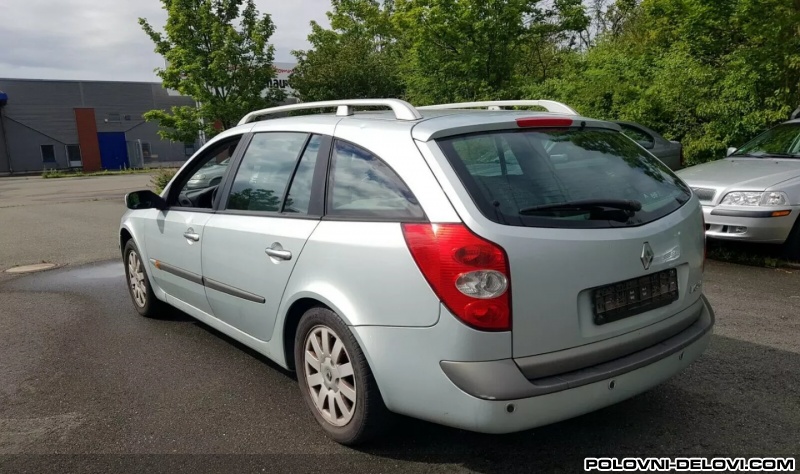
xmin=353 ymin=297 xmax=714 ymax=433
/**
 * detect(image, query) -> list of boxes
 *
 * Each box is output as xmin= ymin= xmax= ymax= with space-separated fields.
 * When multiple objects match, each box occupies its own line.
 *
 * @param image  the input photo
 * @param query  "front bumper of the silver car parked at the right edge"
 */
xmin=703 ymin=206 xmax=800 ymax=244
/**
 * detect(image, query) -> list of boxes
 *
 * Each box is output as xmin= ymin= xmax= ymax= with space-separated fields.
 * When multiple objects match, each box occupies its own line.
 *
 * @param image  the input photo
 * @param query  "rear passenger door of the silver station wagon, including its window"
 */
xmin=202 ymin=132 xmax=330 ymax=341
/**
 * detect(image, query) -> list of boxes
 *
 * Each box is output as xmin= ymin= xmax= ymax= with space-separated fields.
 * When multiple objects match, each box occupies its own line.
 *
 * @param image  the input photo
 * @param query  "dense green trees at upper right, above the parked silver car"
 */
xmin=526 ymin=0 xmax=800 ymax=163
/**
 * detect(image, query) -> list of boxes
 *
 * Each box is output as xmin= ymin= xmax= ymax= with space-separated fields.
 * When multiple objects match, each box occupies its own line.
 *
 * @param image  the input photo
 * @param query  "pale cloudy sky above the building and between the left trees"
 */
xmin=0 ymin=0 xmax=330 ymax=81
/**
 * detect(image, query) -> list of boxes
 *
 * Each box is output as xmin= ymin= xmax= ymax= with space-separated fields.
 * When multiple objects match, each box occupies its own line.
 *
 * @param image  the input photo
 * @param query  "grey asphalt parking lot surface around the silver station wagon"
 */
xmin=0 ymin=176 xmax=800 ymax=473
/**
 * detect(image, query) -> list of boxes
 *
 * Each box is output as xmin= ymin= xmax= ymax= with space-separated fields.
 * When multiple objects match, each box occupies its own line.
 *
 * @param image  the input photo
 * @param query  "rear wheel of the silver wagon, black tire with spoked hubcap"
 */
xmin=294 ymin=307 xmax=393 ymax=446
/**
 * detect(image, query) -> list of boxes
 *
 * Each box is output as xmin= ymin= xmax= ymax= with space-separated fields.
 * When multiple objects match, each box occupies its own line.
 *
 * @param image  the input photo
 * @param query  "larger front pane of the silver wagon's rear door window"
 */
xmin=227 ymin=132 xmax=308 ymax=212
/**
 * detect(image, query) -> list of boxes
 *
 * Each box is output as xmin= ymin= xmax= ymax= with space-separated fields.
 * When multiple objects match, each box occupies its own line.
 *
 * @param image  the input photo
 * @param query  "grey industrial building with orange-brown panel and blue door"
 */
xmin=0 ymin=63 xmax=294 ymax=176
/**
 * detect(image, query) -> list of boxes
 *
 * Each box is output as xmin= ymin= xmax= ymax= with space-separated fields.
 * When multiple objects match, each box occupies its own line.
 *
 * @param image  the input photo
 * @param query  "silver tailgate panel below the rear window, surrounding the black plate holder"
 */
xmin=484 ymin=201 xmax=704 ymax=358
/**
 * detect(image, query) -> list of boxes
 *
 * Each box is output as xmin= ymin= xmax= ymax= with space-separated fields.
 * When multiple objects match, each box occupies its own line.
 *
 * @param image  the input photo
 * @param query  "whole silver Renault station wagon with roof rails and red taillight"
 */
xmin=119 ymin=99 xmax=714 ymax=444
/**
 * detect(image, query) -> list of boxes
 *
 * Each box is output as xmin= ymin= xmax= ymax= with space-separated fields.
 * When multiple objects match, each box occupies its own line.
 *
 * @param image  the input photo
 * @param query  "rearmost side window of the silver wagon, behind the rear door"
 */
xmin=326 ymin=141 xmax=425 ymax=220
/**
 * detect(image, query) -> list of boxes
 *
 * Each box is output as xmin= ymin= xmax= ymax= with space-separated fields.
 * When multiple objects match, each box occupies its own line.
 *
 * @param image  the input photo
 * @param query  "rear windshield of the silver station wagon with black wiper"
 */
xmin=438 ymin=128 xmax=691 ymax=228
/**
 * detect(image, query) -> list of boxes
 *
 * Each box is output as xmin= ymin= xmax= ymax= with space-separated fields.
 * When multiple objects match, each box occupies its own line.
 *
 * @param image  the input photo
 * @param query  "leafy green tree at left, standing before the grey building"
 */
xmin=139 ymin=0 xmax=284 ymax=142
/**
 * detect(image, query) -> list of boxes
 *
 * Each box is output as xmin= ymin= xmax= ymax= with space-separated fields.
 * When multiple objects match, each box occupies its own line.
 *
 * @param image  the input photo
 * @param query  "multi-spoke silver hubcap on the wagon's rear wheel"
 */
xmin=305 ymin=326 xmax=356 ymax=426
